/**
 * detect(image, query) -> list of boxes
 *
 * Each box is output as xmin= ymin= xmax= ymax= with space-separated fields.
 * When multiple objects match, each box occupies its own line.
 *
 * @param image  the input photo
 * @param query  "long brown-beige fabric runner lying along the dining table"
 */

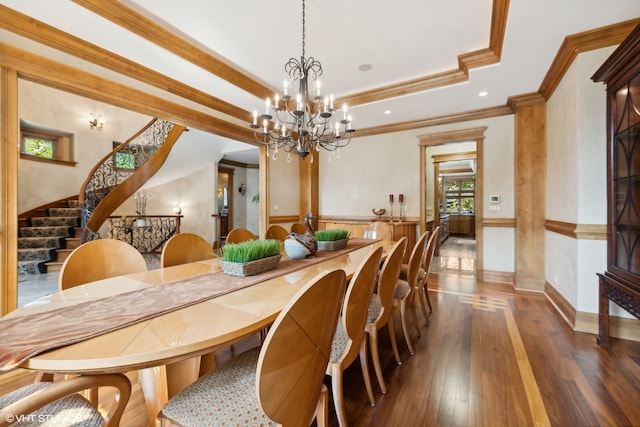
xmin=0 ymin=239 xmax=373 ymax=372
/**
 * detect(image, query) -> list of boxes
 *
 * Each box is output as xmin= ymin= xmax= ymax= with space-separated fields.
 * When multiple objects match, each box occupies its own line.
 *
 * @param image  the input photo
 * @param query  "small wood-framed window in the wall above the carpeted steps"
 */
xmin=20 ymin=120 xmax=75 ymax=164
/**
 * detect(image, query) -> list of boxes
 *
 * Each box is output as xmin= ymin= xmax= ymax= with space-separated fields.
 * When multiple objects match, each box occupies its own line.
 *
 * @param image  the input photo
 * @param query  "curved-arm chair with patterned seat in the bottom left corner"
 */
xmin=0 ymin=374 xmax=131 ymax=427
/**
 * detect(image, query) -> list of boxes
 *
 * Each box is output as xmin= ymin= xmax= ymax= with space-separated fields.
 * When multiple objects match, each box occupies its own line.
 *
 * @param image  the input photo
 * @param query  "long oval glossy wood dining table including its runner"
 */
xmin=0 ymin=239 xmax=392 ymax=426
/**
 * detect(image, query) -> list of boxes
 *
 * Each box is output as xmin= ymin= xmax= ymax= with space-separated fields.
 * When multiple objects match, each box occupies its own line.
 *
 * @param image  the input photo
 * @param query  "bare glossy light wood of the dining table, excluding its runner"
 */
xmin=0 ymin=241 xmax=391 ymax=425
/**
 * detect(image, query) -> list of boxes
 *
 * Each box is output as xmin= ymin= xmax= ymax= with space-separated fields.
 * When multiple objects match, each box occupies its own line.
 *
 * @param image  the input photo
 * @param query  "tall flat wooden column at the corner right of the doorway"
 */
xmin=509 ymin=93 xmax=547 ymax=291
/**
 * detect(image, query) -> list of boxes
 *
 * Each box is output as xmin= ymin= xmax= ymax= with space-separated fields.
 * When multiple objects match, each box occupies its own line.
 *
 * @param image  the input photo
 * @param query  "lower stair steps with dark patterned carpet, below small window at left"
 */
xmin=18 ymin=200 xmax=81 ymax=275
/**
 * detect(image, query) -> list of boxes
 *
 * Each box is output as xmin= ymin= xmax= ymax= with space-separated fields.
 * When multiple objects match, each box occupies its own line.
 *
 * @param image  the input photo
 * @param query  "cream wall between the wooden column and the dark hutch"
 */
xmin=545 ymin=47 xmax=616 ymax=316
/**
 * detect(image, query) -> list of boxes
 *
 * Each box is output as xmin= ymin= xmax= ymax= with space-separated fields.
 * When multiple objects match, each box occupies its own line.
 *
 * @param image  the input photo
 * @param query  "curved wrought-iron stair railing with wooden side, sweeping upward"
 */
xmin=79 ymin=119 xmax=185 ymax=242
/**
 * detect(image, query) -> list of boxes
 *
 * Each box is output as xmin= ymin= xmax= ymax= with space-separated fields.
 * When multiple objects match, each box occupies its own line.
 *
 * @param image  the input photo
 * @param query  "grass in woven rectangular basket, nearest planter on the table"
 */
xmin=220 ymin=239 xmax=281 ymax=277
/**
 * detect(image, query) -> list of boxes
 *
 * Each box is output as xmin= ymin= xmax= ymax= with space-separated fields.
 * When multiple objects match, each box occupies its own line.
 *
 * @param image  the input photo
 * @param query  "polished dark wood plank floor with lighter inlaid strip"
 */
xmin=0 ymin=239 xmax=640 ymax=427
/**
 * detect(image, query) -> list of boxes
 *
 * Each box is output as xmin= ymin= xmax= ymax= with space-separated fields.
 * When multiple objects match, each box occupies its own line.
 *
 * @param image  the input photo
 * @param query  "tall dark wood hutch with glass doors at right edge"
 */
xmin=592 ymin=25 xmax=640 ymax=348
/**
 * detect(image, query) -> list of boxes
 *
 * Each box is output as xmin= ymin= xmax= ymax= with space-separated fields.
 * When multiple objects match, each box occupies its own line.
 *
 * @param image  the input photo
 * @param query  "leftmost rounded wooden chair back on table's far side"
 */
xmin=58 ymin=239 xmax=147 ymax=290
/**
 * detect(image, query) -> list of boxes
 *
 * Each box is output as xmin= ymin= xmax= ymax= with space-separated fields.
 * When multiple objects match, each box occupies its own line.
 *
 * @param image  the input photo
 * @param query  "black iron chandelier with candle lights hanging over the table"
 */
xmin=250 ymin=0 xmax=355 ymax=162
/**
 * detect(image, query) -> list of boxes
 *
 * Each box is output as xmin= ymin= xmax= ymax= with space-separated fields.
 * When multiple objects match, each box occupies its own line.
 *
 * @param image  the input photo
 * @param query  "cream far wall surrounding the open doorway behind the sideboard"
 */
xmin=320 ymin=115 xmax=515 ymax=272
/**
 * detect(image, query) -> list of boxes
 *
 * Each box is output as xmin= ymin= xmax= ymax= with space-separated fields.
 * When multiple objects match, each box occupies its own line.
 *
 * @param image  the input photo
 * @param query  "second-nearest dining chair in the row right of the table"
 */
xmin=326 ymin=247 xmax=382 ymax=426
